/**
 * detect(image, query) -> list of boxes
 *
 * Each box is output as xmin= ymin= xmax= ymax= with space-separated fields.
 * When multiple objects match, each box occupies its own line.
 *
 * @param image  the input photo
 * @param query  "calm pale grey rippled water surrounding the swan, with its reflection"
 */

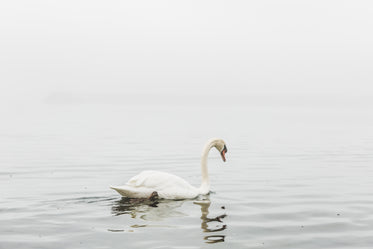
xmin=0 ymin=98 xmax=373 ymax=248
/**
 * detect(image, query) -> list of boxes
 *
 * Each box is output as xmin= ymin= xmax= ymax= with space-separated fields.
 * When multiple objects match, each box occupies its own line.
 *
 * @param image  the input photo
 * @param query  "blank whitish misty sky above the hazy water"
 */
xmin=0 ymin=0 xmax=373 ymax=108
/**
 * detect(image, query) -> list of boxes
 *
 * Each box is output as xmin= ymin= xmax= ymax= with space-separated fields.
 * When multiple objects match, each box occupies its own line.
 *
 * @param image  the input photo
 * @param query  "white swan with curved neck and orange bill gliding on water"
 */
xmin=110 ymin=138 xmax=228 ymax=200
